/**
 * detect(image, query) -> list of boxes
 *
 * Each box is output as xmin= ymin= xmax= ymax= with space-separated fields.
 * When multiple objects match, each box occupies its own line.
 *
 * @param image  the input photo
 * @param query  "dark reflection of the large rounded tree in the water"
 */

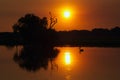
xmin=13 ymin=45 xmax=59 ymax=71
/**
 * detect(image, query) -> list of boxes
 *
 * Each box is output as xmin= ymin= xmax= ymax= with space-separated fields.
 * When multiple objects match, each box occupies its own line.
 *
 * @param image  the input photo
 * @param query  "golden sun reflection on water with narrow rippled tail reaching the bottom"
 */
xmin=56 ymin=47 xmax=79 ymax=80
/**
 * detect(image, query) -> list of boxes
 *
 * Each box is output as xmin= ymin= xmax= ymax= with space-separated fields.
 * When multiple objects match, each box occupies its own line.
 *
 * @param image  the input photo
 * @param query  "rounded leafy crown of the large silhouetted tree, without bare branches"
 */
xmin=13 ymin=14 xmax=48 ymax=37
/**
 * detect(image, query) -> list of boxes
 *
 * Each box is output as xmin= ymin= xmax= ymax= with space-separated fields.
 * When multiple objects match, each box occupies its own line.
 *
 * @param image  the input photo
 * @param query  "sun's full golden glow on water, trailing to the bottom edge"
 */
xmin=55 ymin=47 xmax=82 ymax=80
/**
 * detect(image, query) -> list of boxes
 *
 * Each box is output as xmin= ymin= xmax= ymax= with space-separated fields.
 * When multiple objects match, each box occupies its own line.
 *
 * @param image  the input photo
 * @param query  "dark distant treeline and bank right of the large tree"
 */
xmin=58 ymin=26 xmax=120 ymax=47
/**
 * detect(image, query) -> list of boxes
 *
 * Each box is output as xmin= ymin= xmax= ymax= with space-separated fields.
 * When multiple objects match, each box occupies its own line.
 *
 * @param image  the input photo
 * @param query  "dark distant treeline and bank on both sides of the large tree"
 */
xmin=0 ymin=26 xmax=120 ymax=47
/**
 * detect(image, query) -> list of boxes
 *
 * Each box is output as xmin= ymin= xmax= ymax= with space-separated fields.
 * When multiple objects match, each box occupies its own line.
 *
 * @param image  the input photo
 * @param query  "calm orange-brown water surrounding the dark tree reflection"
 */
xmin=0 ymin=46 xmax=120 ymax=80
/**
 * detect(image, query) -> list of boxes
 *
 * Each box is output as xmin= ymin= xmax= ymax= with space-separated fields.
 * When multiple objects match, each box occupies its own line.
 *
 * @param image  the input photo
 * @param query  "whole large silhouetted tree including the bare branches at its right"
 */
xmin=13 ymin=13 xmax=57 ymax=43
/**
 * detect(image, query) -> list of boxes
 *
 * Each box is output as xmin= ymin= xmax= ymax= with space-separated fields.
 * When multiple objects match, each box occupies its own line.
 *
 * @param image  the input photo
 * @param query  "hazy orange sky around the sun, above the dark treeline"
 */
xmin=0 ymin=0 xmax=120 ymax=32
